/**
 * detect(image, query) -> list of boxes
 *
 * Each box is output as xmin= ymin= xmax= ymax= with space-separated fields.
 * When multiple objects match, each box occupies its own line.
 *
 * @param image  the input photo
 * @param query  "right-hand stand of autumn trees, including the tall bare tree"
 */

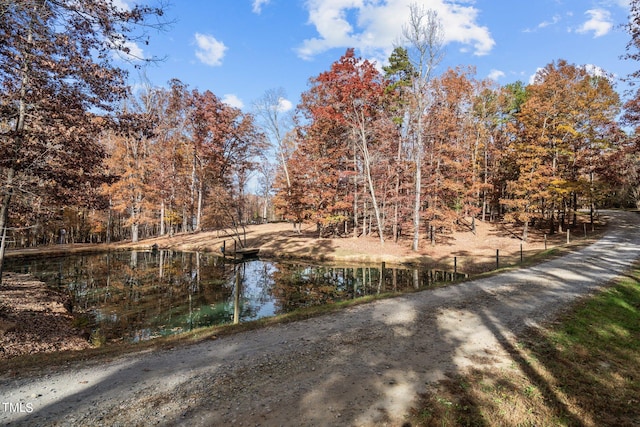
xmin=275 ymin=6 xmax=637 ymax=249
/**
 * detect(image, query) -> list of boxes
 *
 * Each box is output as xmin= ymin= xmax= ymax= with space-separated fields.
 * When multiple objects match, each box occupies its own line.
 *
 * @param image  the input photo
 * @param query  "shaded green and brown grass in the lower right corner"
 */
xmin=410 ymin=266 xmax=640 ymax=426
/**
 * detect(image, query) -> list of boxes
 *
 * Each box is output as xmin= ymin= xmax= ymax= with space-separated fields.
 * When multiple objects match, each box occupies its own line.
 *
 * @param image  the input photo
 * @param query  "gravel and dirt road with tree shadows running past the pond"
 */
xmin=0 ymin=212 xmax=640 ymax=426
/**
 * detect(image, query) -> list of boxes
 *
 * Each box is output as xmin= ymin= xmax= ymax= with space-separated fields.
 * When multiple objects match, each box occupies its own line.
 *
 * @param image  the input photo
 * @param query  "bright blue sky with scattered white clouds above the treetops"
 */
xmin=116 ymin=0 xmax=640 ymax=112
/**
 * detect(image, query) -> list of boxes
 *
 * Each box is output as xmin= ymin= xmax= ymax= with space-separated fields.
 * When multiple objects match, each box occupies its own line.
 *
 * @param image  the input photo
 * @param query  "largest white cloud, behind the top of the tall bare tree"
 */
xmin=298 ymin=0 xmax=495 ymax=59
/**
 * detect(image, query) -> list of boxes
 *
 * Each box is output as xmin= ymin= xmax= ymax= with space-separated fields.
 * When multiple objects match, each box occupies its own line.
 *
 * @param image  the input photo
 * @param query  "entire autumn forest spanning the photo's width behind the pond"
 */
xmin=0 ymin=0 xmax=640 ymax=274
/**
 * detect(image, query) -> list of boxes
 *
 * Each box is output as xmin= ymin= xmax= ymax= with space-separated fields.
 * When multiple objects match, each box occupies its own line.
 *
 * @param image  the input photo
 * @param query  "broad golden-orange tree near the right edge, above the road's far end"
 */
xmin=502 ymin=60 xmax=619 ymax=240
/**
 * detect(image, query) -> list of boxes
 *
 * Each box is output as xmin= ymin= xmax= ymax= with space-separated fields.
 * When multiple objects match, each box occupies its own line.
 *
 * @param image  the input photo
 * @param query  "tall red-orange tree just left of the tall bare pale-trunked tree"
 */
xmin=280 ymin=49 xmax=397 ymax=243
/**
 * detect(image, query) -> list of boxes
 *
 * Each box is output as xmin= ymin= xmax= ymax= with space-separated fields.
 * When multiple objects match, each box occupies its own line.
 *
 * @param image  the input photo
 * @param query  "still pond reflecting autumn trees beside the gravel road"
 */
xmin=5 ymin=250 xmax=463 ymax=342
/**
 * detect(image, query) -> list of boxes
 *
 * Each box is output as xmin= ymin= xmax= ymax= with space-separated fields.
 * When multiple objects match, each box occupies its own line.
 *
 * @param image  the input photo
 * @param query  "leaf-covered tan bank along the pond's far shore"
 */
xmin=5 ymin=217 xmax=606 ymax=273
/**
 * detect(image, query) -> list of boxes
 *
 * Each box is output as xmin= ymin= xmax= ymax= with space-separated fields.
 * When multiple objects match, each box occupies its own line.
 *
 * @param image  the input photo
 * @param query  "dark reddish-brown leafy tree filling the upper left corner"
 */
xmin=0 ymin=0 xmax=162 ymax=282
